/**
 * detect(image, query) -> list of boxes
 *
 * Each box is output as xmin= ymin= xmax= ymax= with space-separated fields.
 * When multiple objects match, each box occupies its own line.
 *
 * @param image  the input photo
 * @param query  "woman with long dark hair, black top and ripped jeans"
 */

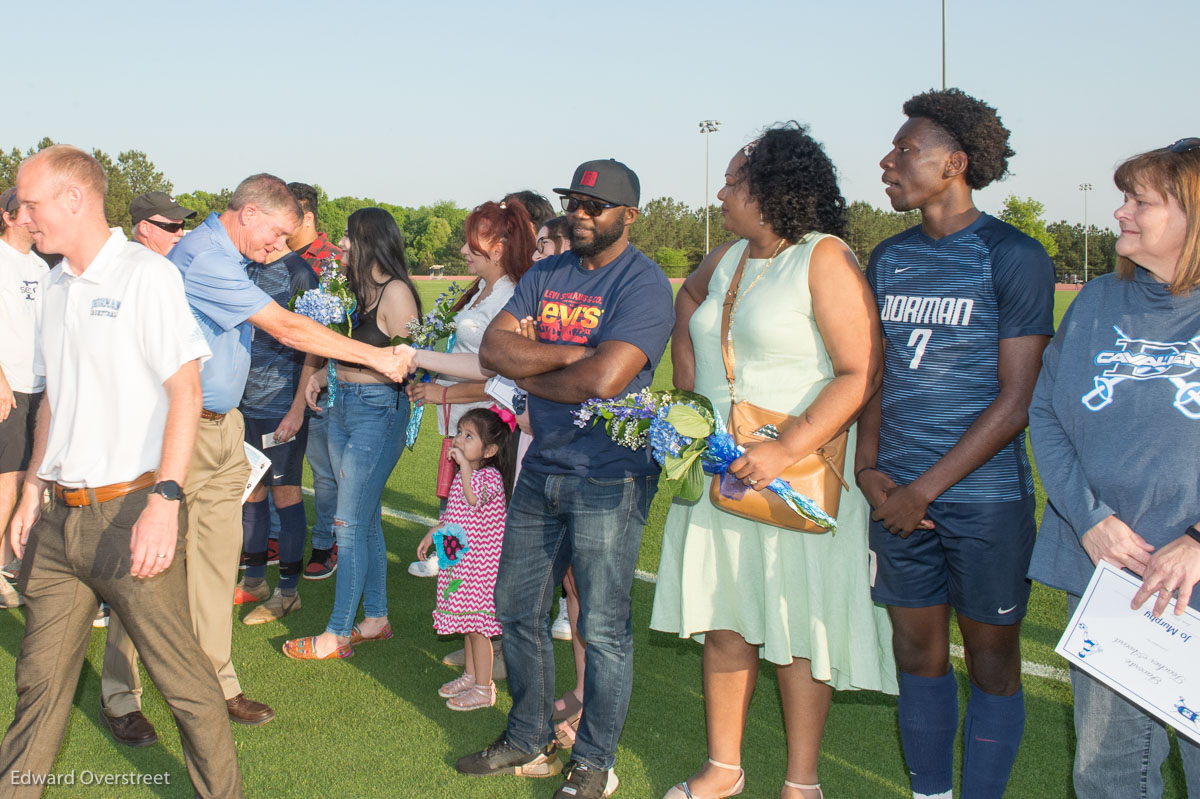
xmin=283 ymin=208 xmax=421 ymax=660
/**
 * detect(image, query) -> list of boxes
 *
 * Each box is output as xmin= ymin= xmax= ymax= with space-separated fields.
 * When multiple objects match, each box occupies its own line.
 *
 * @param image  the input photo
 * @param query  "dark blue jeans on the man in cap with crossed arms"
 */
xmin=496 ymin=469 xmax=659 ymax=769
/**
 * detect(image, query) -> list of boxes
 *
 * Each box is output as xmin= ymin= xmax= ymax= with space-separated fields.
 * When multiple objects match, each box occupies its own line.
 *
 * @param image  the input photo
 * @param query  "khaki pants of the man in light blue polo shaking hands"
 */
xmin=100 ymin=410 xmax=250 ymax=716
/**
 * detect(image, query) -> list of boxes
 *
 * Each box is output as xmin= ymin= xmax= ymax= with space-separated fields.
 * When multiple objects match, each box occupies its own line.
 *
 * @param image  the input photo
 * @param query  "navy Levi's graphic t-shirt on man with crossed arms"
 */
xmin=504 ymin=245 xmax=674 ymax=477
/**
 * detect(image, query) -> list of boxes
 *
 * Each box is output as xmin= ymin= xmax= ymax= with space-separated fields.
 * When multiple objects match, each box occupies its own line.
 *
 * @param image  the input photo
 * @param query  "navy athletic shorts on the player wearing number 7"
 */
xmin=870 ymin=497 xmax=1037 ymax=625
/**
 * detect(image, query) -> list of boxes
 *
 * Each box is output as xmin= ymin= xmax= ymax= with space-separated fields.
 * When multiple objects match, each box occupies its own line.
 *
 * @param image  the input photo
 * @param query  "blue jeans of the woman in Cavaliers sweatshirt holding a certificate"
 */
xmin=1067 ymin=594 xmax=1200 ymax=799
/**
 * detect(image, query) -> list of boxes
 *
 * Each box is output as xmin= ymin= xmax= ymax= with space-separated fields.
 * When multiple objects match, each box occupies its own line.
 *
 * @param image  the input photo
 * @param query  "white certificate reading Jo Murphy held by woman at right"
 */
xmin=1055 ymin=560 xmax=1200 ymax=743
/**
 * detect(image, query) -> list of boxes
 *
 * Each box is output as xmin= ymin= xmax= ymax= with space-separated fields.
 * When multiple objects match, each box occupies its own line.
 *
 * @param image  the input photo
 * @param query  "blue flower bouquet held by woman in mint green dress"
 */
xmin=575 ymin=389 xmax=838 ymax=530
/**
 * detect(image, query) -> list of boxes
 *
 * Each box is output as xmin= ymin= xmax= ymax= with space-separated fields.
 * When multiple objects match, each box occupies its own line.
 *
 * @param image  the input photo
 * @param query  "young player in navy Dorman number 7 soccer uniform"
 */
xmin=854 ymin=89 xmax=1054 ymax=799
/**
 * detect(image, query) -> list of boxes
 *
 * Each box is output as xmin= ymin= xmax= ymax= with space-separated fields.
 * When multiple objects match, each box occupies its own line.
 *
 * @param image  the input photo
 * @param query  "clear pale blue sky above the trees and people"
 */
xmin=11 ymin=0 xmax=1200 ymax=230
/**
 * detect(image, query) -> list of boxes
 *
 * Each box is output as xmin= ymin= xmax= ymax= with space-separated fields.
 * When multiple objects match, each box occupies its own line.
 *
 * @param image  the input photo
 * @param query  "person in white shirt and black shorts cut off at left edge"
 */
xmin=0 ymin=186 xmax=47 ymax=607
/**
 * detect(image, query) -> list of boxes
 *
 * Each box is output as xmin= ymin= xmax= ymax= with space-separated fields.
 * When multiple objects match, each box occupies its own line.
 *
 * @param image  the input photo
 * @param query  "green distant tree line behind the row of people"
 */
xmin=0 ymin=138 xmax=1116 ymax=282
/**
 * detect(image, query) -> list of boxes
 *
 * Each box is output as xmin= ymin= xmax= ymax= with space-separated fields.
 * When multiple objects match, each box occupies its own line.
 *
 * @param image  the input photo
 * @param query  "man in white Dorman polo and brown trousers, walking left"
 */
xmin=0 ymin=145 xmax=241 ymax=797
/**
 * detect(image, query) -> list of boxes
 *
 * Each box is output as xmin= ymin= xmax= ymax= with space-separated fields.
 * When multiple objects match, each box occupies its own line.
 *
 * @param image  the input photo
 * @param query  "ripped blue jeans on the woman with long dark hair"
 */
xmin=325 ymin=380 xmax=408 ymax=637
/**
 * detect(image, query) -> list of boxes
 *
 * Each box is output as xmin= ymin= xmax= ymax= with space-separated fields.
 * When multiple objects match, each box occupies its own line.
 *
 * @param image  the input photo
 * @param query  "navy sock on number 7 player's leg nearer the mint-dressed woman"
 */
xmin=899 ymin=668 xmax=959 ymax=797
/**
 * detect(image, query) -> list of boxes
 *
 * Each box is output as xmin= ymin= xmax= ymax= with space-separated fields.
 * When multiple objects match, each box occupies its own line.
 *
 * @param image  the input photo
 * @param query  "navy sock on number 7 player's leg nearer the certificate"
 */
xmin=962 ymin=685 xmax=1025 ymax=799
